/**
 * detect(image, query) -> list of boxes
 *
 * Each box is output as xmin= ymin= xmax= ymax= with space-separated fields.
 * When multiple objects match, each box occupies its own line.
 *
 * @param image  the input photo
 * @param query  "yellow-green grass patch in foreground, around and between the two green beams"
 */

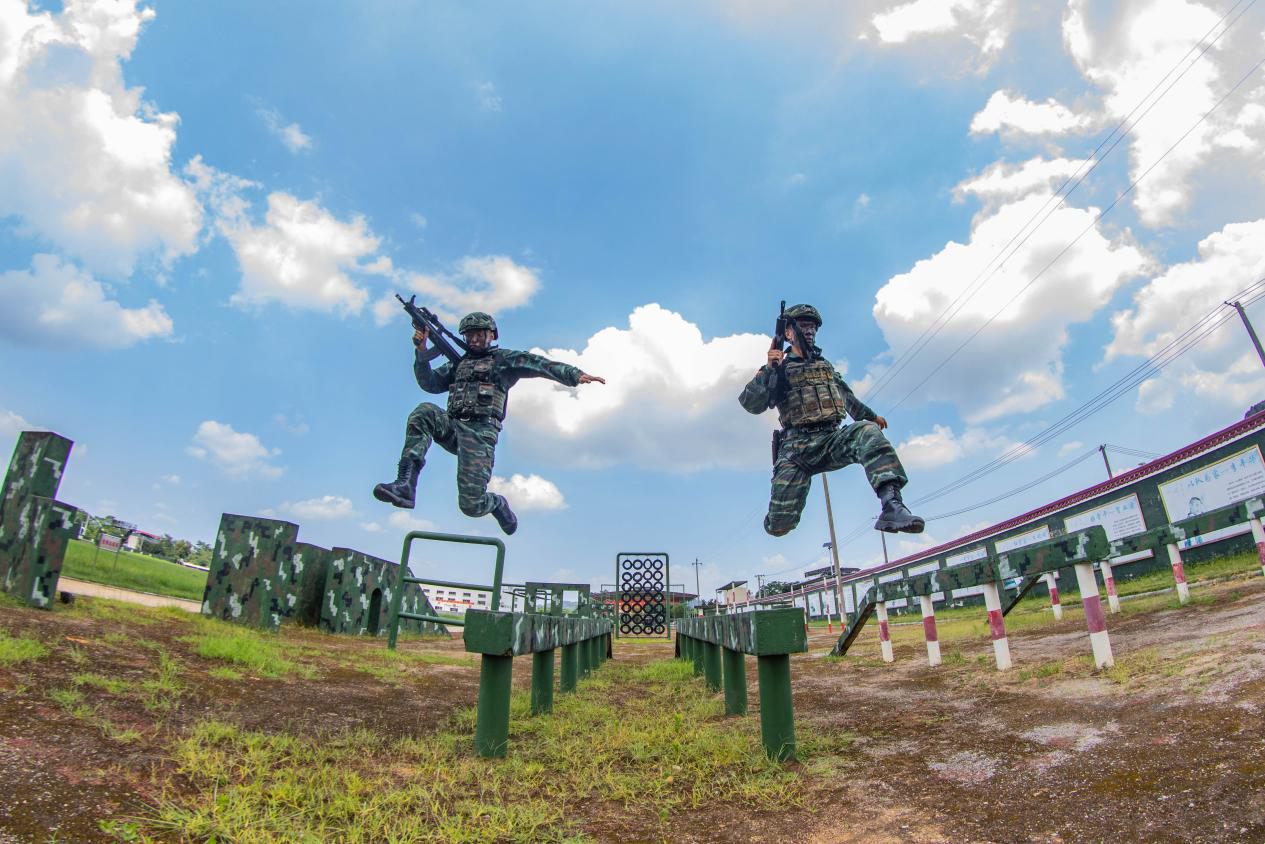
xmin=137 ymin=661 xmax=851 ymax=844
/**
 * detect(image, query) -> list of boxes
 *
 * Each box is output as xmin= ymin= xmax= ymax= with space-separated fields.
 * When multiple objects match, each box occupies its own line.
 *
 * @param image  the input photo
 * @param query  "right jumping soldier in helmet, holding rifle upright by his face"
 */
xmin=739 ymin=305 xmax=923 ymax=537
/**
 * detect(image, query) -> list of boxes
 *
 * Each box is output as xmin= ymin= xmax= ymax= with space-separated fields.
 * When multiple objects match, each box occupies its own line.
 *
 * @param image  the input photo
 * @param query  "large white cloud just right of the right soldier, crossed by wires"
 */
xmin=856 ymin=192 xmax=1150 ymax=424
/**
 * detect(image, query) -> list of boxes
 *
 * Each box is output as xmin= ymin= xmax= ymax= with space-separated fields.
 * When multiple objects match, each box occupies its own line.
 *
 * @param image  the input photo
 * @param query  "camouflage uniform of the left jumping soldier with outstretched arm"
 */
xmin=401 ymin=348 xmax=583 ymax=516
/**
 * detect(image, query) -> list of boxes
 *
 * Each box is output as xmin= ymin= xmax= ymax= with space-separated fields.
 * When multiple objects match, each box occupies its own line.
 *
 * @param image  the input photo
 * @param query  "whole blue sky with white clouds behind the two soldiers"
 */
xmin=0 ymin=0 xmax=1265 ymax=592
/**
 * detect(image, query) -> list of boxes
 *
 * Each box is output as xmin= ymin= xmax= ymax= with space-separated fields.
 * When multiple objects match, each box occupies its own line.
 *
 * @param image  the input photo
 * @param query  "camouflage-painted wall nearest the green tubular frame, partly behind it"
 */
xmin=320 ymin=548 xmax=447 ymax=636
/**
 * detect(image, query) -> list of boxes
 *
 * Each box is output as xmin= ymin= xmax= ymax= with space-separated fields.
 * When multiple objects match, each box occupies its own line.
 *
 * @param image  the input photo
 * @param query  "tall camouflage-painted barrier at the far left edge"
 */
xmin=0 ymin=431 xmax=76 ymax=609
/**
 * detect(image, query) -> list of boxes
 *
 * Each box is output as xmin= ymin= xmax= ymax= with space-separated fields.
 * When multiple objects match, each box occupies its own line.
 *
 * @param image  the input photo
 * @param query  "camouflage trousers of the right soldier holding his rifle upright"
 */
xmin=764 ymin=421 xmax=910 ymax=537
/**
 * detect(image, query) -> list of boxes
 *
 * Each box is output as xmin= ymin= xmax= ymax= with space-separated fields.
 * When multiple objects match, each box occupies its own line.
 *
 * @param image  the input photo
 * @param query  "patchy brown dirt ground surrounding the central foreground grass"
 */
xmin=0 ymin=577 xmax=1265 ymax=844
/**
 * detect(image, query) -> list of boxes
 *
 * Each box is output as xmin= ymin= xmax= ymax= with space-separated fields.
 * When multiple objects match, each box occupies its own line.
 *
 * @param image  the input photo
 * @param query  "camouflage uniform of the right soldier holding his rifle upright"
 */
xmin=737 ymin=352 xmax=908 ymax=537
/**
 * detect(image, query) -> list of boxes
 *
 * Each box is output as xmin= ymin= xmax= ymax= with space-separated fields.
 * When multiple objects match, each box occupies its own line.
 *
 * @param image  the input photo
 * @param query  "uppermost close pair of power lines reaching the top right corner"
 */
xmin=865 ymin=0 xmax=1256 ymax=401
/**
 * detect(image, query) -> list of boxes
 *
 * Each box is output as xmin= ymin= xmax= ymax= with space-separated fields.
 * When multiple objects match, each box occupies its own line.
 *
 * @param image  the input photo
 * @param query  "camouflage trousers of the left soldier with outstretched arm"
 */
xmin=401 ymin=401 xmax=501 ymax=516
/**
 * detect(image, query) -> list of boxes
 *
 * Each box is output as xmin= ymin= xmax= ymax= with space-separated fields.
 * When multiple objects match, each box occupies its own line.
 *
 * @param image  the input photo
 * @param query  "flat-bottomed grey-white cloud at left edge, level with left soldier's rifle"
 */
xmin=0 ymin=254 xmax=172 ymax=348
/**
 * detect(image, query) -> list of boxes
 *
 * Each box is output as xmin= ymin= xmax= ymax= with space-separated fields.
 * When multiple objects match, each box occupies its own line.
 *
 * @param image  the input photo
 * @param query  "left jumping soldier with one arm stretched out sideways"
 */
xmin=373 ymin=311 xmax=606 ymax=534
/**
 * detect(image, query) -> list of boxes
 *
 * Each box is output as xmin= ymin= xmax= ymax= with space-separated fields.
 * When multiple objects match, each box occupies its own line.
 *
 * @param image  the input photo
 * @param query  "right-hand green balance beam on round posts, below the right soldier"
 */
xmin=677 ymin=607 xmax=808 ymax=762
